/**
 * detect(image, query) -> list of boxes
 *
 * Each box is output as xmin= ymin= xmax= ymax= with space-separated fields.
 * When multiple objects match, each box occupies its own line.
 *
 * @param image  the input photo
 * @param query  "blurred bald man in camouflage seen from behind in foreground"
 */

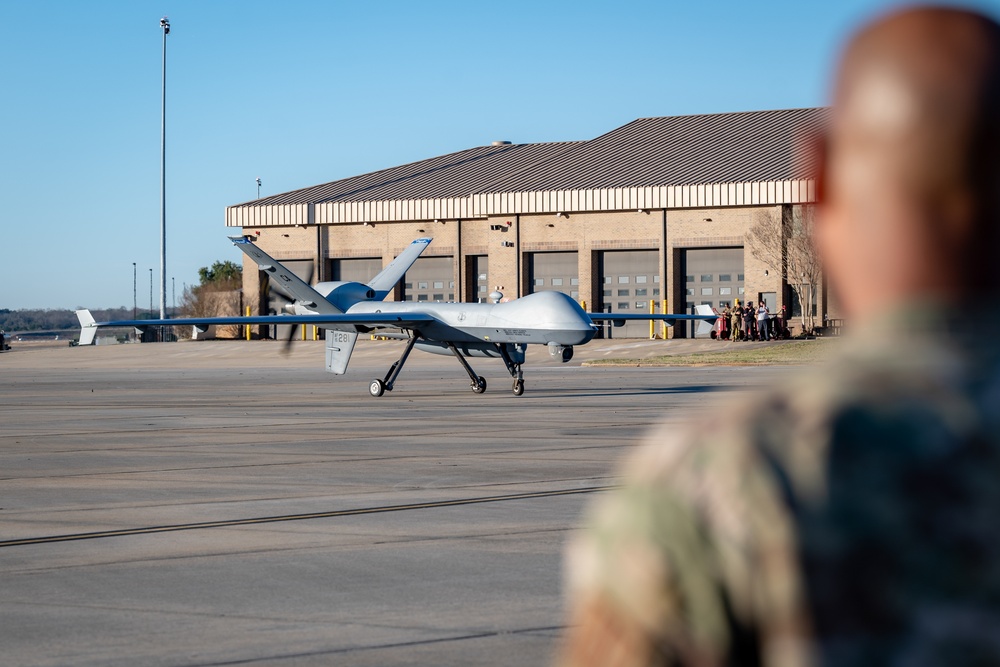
xmin=560 ymin=8 xmax=1000 ymax=665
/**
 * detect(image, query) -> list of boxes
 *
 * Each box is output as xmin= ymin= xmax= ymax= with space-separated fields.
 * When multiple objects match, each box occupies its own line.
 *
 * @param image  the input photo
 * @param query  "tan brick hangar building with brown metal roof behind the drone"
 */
xmin=226 ymin=108 xmax=828 ymax=337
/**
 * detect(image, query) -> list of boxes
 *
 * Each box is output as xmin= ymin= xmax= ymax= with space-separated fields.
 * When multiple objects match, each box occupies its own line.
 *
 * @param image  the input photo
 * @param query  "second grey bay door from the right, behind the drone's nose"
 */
xmin=598 ymin=250 xmax=662 ymax=338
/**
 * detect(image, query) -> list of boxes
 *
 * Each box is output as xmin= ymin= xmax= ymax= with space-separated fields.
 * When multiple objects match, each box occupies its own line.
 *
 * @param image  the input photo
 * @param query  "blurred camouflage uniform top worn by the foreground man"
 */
xmin=563 ymin=306 xmax=1000 ymax=666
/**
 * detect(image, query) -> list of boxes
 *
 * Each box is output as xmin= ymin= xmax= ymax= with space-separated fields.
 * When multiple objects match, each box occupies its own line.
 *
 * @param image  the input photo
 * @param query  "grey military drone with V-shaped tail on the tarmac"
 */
xmin=77 ymin=236 xmax=717 ymax=396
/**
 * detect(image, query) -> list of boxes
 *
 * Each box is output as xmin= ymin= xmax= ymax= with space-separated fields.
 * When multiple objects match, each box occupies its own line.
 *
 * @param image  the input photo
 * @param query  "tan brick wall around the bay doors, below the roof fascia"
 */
xmin=234 ymin=206 xmax=804 ymax=336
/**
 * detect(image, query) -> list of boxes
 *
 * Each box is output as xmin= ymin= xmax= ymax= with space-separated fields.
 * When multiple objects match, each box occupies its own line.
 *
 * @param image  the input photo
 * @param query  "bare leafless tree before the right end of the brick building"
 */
xmin=745 ymin=206 xmax=823 ymax=333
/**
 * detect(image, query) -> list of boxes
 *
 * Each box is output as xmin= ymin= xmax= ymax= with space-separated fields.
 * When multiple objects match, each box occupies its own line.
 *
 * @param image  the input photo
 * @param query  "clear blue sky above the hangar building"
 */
xmin=0 ymin=0 xmax=1000 ymax=309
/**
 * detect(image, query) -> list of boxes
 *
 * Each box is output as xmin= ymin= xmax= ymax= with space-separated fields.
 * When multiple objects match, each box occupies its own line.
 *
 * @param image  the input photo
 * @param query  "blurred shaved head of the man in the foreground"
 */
xmin=817 ymin=8 xmax=1000 ymax=317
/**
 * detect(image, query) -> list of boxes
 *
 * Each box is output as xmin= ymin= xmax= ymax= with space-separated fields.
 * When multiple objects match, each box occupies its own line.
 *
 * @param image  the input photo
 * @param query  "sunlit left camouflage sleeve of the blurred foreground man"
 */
xmin=561 ymin=420 xmax=810 ymax=665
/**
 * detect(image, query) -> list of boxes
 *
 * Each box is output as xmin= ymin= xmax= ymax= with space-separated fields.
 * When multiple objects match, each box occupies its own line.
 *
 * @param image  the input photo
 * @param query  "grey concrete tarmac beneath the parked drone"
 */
xmin=0 ymin=340 xmax=795 ymax=666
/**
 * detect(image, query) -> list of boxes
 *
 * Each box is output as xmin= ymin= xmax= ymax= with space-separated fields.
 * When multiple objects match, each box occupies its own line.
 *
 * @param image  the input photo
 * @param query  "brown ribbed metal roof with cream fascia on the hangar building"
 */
xmin=226 ymin=108 xmax=827 ymax=226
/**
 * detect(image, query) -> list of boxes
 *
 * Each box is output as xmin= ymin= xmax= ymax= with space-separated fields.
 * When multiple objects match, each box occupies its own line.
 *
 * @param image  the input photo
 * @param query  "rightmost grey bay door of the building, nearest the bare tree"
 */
xmin=681 ymin=248 xmax=744 ymax=338
